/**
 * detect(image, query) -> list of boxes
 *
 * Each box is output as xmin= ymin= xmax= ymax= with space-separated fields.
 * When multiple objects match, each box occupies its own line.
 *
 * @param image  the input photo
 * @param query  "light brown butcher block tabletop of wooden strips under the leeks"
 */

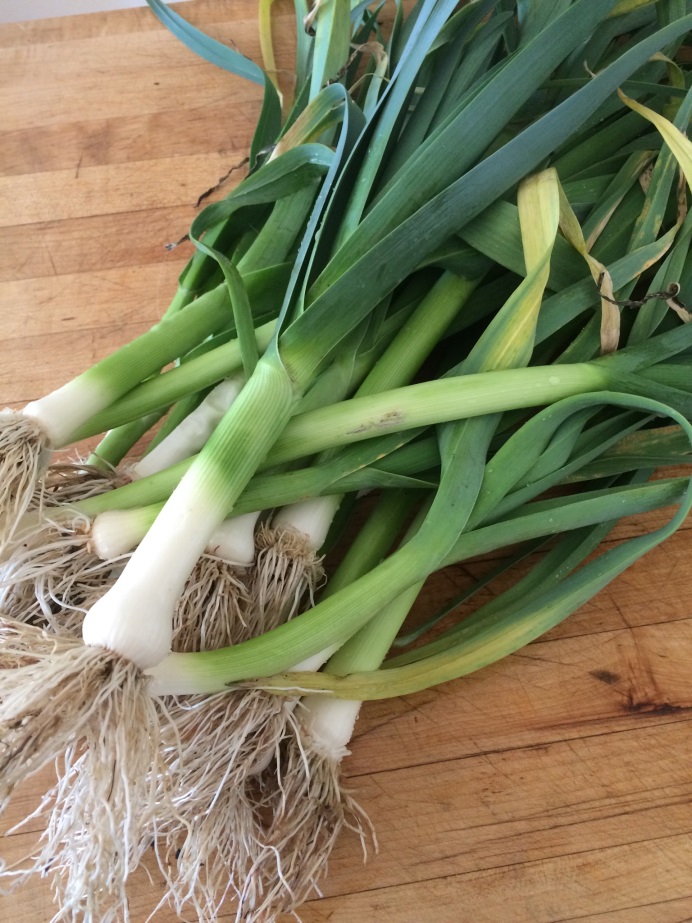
xmin=0 ymin=0 xmax=692 ymax=923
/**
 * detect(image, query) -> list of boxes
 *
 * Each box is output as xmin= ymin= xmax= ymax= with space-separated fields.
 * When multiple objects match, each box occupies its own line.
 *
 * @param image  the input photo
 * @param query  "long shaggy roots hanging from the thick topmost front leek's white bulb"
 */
xmin=0 ymin=625 xmax=174 ymax=923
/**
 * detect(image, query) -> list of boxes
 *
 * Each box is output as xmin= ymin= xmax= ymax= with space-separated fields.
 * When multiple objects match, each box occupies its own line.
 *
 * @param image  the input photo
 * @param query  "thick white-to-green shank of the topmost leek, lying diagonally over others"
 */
xmin=83 ymin=356 xmax=295 ymax=670
